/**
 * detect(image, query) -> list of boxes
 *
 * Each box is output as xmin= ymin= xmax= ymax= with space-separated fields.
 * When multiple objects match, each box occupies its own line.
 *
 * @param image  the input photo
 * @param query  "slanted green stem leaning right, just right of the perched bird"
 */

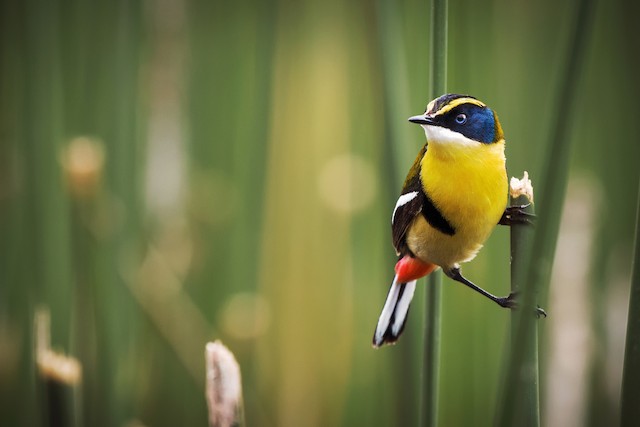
xmin=496 ymin=0 xmax=595 ymax=427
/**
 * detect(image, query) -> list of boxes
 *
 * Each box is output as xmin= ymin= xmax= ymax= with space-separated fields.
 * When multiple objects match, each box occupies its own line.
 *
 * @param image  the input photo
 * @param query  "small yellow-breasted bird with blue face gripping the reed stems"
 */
xmin=373 ymin=94 xmax=524 ymax=347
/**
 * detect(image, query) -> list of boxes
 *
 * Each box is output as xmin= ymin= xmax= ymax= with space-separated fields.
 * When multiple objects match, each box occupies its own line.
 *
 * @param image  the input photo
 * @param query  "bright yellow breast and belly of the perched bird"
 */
xmin=407 ymin=141 xmax=507 ymax=269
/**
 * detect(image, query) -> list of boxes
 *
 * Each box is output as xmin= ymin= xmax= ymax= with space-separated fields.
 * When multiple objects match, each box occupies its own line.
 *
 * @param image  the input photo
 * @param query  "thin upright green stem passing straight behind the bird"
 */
xmin=421 ymin=0 xmax=448 ymax=426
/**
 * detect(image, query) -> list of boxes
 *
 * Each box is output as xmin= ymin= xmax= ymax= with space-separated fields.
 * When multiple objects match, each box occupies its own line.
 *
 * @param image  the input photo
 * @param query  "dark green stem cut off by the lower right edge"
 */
xmin=620 ymin=182 xmax=640 ymax=427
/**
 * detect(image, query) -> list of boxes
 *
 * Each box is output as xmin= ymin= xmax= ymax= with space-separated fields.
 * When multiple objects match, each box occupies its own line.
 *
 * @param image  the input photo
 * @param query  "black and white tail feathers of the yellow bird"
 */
xmin=373 ymin=276 xmax=416 ymax=348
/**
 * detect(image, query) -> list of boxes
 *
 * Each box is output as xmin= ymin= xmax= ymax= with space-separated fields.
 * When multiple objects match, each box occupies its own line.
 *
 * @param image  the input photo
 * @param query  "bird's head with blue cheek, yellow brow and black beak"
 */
xmin=409 ymin=94 xmax=504 ymax=146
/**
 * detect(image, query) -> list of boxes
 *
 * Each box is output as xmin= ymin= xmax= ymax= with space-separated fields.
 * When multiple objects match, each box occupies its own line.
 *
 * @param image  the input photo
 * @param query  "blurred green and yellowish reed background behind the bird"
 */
xmin=0 ymin=0 xmax=640 ymax=426
